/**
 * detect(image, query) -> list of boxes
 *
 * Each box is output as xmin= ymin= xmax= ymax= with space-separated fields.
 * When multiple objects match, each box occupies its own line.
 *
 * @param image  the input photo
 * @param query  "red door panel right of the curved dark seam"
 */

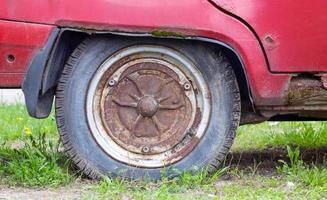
xmin=213 ymin=0 xmax=327 ymax=72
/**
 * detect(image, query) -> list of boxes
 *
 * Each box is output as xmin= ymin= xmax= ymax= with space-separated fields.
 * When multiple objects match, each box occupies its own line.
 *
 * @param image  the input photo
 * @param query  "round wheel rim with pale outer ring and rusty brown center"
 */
xmin=86 ymin=45 xmax=211 ymax=168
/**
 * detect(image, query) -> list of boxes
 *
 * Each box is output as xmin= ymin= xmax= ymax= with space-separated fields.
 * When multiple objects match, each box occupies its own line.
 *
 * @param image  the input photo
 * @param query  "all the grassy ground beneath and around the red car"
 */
xmin=0 ymin=104 xmax=327 ymax=199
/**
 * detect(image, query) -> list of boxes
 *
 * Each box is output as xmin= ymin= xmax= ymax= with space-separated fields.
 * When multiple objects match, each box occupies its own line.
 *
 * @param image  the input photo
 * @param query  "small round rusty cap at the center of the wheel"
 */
xmin=137 ymin=96 xmax=158 ymax=117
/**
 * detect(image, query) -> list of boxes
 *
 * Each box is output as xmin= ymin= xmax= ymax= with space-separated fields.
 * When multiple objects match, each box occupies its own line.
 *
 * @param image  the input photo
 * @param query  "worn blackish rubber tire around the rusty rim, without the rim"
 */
xmin=56 ymin=36 xmax=241 ymax=179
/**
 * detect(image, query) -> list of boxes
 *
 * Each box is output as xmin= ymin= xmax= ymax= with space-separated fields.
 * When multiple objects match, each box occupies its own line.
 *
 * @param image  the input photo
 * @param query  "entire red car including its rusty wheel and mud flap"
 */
xmin=0 ymin=0 xmax=327 ymax=179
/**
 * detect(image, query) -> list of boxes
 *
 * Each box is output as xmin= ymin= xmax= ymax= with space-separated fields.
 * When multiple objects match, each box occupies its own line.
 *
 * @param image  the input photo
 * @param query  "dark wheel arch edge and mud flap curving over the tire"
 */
xmin=22 ymin=28 xmax=254 ymax=118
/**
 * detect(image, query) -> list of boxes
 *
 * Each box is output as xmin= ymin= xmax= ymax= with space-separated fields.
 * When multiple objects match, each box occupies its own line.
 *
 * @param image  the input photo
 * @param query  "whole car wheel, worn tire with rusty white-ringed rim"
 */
xmin=56 ymin=37 xmax=240 ymax=179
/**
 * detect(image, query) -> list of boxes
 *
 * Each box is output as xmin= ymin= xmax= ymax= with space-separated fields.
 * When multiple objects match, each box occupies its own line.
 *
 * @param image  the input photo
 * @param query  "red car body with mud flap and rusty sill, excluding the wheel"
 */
xmin=0 ymin=0 xmax=327 ymax=178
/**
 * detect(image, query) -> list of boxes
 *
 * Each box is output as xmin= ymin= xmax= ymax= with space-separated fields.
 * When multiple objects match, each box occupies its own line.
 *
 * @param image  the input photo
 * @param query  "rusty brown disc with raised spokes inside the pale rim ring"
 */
xmin=101 ymin=60 xmax=192 ymax=154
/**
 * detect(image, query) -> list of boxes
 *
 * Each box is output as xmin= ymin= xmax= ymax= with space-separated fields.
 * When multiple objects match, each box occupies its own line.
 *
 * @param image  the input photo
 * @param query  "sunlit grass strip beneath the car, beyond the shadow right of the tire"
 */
xmin=232 ymin=122 xmax=327 ymax=151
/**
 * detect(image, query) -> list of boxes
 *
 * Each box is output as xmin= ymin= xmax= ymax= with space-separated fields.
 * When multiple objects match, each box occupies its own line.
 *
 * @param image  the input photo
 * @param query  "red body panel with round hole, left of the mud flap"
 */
xmin=0 ymin=20 xmax=53 ymax=87
